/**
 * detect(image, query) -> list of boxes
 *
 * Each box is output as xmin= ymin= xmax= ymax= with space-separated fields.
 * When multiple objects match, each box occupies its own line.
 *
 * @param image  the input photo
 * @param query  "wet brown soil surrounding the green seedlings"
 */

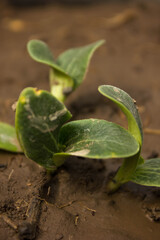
xmin=0 ymin=1 xmax=160 ymax=240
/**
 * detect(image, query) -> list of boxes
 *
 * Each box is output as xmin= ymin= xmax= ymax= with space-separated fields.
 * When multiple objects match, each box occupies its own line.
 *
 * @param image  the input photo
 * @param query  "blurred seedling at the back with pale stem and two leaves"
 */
xmin=27 ymin=40 xmax=105 ymax=102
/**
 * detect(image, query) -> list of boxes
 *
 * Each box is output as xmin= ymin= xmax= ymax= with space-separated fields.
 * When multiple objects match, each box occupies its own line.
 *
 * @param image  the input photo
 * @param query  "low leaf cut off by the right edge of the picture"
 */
xmin=130 ymin=158 xmax=160 ymax=187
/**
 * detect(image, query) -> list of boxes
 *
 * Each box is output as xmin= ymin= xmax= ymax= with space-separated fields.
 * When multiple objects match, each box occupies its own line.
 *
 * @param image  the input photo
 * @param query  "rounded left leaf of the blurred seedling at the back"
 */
xmin=27 ymin=39 xmax=67 ymax=75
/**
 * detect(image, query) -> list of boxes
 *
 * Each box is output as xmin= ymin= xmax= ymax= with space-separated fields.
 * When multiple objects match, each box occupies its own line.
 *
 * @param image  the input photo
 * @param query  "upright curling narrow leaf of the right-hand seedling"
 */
xmin=98 ymin=85 xmax=143 ymax=145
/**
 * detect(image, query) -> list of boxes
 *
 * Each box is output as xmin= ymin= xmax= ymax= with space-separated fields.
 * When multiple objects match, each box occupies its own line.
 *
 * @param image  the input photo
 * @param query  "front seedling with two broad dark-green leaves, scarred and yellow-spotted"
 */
xmin=15 ymin=88 xmax=139 ymax=171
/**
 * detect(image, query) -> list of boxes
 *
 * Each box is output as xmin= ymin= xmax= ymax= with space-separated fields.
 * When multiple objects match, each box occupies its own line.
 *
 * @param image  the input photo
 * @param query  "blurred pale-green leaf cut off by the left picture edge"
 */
xmin=0 ymin=122 xmax=22 ymax=152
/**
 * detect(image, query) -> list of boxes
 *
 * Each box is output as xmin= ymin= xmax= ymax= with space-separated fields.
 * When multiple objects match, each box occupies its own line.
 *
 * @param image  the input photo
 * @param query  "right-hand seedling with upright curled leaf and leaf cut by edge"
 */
xmin=99 ymin=85 xmax=160 ymax=192
